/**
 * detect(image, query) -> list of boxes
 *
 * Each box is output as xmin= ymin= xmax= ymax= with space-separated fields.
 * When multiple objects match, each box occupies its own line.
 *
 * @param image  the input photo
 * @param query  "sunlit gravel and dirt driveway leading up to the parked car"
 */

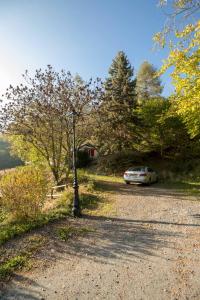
xmin=0 ymin=183 xmax=200 ymax=300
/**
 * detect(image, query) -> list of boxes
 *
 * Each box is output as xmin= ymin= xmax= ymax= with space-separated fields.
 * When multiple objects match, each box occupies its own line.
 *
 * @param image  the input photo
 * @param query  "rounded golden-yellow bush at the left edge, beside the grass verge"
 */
xmin=0 ymin=166 xmax=49 ymax=220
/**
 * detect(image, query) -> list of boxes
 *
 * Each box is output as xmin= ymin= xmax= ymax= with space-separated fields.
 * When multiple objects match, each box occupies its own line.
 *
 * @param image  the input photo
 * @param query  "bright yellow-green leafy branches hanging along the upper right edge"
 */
xmin=161 ymin=21 xmax=200 ymax=138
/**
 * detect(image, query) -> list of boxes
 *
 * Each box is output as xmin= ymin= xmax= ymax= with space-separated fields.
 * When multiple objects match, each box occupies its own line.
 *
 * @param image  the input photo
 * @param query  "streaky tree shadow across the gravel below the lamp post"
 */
xmin=37 ymin=216 xmax=181 ymax=264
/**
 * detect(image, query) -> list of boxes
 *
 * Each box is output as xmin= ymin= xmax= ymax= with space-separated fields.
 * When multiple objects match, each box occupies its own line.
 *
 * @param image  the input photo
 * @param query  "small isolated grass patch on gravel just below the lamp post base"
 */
xmin=56 ymin=225 xmax=94 ymax=242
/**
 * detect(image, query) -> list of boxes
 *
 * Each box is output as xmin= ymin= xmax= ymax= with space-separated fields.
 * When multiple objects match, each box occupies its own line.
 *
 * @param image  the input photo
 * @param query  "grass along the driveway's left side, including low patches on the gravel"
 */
xmin=0 ymin=169 xmax=116 ymax=286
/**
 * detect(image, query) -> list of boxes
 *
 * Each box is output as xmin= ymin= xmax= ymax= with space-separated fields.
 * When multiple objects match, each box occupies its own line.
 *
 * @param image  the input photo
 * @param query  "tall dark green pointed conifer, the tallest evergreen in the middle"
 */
xmin=97 ymin=51 xmax=135 ymax=152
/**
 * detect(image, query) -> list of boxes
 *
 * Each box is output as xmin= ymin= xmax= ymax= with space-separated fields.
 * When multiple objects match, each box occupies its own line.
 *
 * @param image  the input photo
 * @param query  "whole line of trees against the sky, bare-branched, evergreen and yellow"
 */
xmin=0 ymin=0 xmax=200 ymax=183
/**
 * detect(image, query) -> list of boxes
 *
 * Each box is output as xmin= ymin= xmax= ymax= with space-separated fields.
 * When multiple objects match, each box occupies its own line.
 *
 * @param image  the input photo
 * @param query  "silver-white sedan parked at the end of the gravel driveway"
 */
xmin=124 ymin=166 xmax=158 ymax=184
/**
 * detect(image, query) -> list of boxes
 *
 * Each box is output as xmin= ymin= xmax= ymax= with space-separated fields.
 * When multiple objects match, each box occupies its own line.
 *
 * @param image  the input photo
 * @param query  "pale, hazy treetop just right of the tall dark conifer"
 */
xmin=136 ymin=61 xmax=163 ymax=103
